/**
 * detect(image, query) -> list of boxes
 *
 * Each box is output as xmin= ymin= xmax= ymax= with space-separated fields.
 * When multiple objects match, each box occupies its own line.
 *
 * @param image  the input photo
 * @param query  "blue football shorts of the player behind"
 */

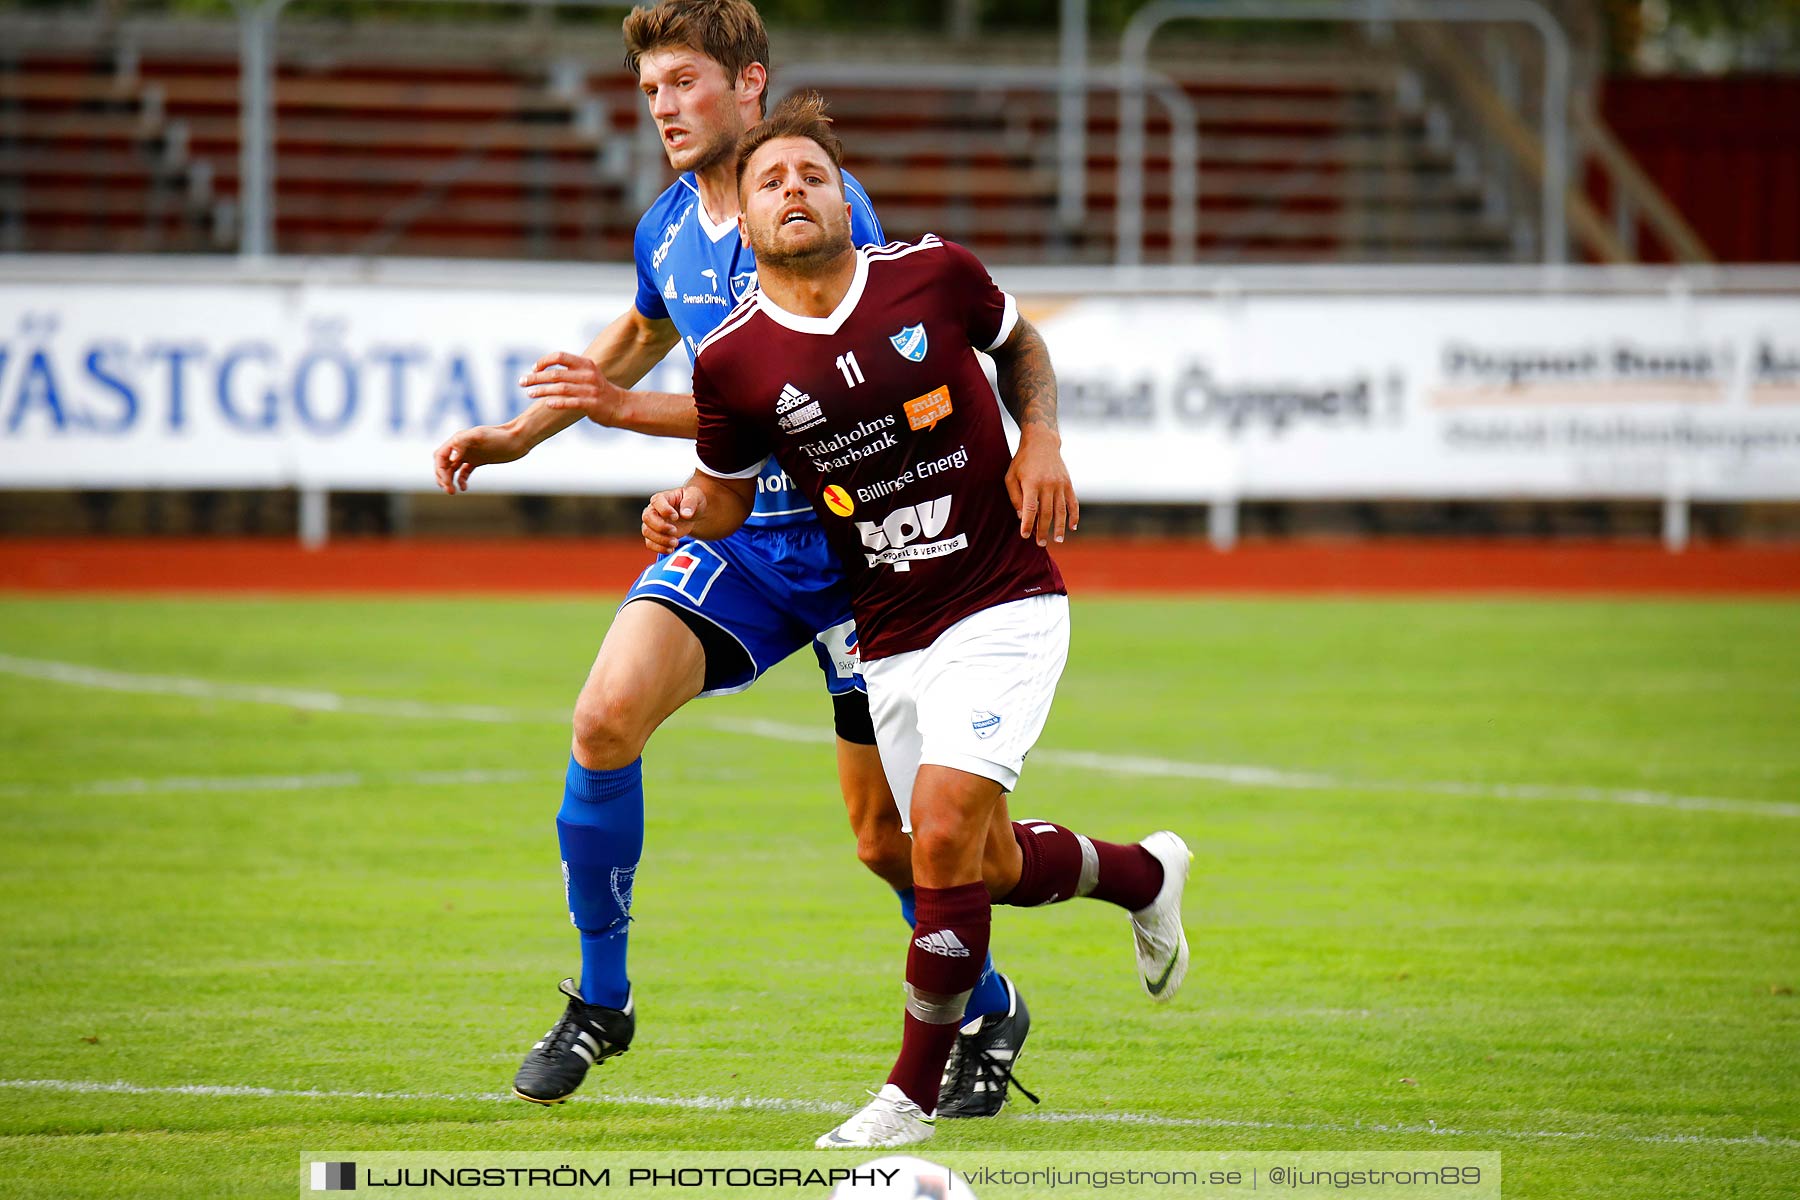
xmin=621 ymin=522 xmax=868 ymax=696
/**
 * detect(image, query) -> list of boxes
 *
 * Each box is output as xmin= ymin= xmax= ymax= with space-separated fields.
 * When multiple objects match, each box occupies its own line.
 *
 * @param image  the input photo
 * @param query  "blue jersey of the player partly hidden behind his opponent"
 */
xmin=632 ymin=171 xmax=887 ymax=529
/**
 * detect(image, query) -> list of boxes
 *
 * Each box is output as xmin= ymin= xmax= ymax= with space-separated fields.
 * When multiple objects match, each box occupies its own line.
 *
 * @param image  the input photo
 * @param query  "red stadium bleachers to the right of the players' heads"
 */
xmin=796 ymin=47 xmax=1508 ymax=263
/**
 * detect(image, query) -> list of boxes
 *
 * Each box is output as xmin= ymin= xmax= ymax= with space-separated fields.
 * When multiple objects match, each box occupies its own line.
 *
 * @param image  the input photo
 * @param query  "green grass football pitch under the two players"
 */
xmin=0 ymin=597 xmax=1800 ymax=1200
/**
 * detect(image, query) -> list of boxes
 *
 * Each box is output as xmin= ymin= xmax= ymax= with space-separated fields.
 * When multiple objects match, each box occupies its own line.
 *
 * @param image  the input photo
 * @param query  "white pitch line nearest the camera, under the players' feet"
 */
xmin=0 ymin=1079 xmax=1800 ymax=1150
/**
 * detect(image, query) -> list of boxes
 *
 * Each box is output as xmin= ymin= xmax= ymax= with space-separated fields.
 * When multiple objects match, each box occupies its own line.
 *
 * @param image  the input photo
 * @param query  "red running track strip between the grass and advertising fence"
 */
xmin=0 ymin=538 xmax=1800 ymax=596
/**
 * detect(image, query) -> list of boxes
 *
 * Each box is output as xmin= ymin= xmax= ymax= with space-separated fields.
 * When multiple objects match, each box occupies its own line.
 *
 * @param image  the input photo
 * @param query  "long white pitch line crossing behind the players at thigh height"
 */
xmin=0 ymin=655 xmax=1800 ymax=819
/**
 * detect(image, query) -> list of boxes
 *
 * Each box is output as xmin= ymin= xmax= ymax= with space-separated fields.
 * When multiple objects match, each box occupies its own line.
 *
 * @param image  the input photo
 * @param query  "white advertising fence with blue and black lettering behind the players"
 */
xmin=0 ymin=259 xmax=1800 ymax=546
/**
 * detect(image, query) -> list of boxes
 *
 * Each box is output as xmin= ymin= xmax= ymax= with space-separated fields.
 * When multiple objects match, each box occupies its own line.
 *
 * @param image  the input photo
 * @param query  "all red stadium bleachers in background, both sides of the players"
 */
xmin=0 ymin=26 xmax=1519 ymax=263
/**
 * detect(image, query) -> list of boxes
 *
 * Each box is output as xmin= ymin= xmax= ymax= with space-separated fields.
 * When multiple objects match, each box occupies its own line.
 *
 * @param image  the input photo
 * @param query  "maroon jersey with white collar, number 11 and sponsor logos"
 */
xmin=693 ymin=234 xmax=1064 ymax=660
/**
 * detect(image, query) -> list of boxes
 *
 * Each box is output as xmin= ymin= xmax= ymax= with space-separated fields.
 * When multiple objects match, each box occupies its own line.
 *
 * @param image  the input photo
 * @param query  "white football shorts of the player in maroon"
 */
xmin=862 ymin=596 xmax=1069 ymax=833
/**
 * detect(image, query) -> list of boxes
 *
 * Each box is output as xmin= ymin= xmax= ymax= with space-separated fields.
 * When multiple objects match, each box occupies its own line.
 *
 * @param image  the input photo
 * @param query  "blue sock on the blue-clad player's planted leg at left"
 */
xmin=556 ymin=754 xmax=644 ymax=1007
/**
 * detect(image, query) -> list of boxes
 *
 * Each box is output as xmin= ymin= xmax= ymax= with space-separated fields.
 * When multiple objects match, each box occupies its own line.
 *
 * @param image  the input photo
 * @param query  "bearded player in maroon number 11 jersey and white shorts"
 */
xmin=612 ymin=94 xmax=1190 ymax=1148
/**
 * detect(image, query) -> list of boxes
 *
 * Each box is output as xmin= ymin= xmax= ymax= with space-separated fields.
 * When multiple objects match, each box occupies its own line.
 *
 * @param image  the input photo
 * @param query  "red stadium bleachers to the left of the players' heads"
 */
xmin=0 ymin=56 xmax=648 ymax=257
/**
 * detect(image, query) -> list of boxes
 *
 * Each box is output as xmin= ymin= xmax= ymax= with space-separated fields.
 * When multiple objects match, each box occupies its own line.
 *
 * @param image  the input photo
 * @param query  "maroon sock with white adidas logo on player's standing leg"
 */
xmin=887 ymin=883 xmax=994 ymax=1114
